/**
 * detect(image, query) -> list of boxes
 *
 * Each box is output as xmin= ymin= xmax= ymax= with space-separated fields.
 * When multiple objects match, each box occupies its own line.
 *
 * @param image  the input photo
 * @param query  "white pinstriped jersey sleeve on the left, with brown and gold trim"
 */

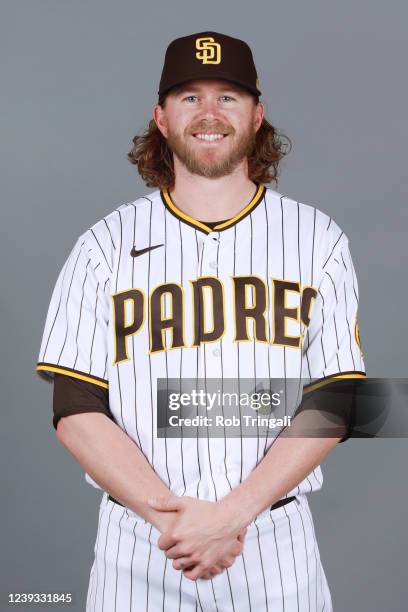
xmin=35 ymin=233 xmax=109 ymax=389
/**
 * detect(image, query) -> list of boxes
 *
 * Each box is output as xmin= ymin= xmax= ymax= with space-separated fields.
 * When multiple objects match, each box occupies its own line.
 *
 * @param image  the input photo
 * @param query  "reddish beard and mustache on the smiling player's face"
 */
xmin=167 ymin=119 xmax=256 ymax=178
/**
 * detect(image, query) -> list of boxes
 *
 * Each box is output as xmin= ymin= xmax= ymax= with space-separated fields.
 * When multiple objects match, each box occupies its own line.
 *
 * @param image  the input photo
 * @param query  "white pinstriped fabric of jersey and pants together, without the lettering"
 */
xmin=37 ymin=189 xmax=365 ymax=612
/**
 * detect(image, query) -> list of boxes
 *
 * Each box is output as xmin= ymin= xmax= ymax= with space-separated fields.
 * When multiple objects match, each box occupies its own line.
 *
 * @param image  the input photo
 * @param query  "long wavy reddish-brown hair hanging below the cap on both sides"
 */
xmin=127 ymin=91 xmax=292 ymax=190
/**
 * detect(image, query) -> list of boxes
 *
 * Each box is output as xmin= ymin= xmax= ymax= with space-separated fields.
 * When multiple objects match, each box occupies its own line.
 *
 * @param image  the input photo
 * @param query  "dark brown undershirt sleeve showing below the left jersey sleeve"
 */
xmin=52 ymin=373 xmax=114 ymax=430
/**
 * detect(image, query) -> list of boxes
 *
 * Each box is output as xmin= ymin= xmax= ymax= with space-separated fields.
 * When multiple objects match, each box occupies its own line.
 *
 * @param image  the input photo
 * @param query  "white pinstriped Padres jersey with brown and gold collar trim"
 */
xmin=36 ymin=184 xmax=365 ymax=500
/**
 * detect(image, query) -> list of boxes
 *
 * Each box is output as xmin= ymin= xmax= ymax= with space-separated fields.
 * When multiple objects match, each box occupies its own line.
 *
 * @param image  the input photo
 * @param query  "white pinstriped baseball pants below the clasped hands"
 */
xmin=86 ymin=494 xmax=332 ymax=612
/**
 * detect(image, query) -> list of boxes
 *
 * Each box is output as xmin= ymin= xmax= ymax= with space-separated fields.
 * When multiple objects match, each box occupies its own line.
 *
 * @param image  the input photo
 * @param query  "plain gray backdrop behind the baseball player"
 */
xmin=0 ymin=0 xmax=408 ymax=612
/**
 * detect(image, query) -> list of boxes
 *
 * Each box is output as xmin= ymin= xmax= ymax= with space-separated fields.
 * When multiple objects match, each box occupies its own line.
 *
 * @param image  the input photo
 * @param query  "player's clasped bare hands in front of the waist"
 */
xmin=148 ymin=495 xmax=247 ymax=580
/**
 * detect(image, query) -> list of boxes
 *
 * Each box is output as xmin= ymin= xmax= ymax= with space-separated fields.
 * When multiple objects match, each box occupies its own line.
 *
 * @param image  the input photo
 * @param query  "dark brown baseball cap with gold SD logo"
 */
xmin=158 ymin=31 xmax=261 ymax=100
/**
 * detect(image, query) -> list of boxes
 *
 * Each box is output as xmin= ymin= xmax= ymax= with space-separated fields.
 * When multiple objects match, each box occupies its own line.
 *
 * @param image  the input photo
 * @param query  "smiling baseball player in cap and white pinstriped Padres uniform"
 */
xmin=36 ymin=32 xmax=366 ymax=612
